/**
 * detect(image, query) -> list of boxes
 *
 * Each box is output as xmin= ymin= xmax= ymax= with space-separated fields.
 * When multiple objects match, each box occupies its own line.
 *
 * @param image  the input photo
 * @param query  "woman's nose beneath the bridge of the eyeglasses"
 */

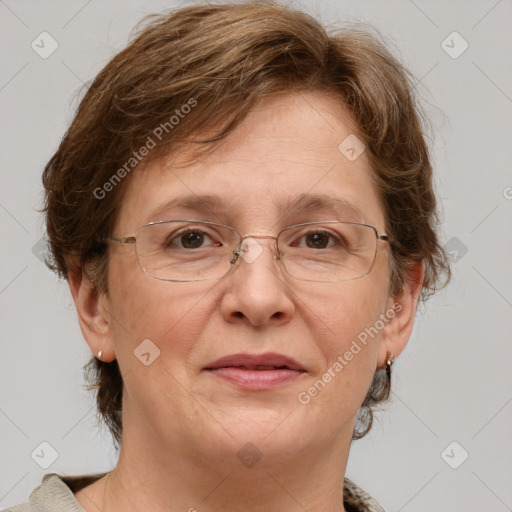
xmin=221 ymin=235 xmax=295 ymax=327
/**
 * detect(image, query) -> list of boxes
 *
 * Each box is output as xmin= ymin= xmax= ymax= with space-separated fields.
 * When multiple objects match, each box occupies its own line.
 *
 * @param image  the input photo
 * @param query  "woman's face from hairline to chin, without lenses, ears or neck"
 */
xmin=96 ymin=93 xmax=400 ymax=464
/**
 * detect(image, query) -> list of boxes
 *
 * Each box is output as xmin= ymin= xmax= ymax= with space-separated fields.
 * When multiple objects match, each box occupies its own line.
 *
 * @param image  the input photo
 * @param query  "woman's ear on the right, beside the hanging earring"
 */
xmin=378 ymin=262 xmax=425 ymax=368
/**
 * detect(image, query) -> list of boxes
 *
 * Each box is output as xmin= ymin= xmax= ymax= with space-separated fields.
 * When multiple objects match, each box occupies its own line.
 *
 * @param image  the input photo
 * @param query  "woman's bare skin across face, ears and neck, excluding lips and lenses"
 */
xmin=70 ymin=92 xmax=422 ymax=512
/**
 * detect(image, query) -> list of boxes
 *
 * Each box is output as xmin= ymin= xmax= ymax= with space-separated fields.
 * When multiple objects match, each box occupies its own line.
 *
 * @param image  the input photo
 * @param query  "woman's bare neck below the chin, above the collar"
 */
xmin=97 ymin=422 xmax=350 ymax=512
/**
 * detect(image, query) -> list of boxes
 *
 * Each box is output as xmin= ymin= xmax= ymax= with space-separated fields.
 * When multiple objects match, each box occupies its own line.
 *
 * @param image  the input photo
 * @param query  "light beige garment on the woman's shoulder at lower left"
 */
xmin=5 ymin=473 xmax=85 ymax=512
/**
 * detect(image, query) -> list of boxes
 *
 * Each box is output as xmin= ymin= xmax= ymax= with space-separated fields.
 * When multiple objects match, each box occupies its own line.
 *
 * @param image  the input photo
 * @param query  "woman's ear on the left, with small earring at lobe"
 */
xmin=68 ymin=266 xmax=116 ymax=363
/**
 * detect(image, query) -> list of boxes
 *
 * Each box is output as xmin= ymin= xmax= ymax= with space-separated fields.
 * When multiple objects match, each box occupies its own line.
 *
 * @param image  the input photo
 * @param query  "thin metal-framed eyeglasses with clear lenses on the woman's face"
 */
xmin=105 ymin=220 xmax=389 ymax=282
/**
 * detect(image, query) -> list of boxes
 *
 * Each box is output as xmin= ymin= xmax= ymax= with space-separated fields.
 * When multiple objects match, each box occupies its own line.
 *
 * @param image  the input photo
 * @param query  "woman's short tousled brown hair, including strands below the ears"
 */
xmin=43 ymin=1 xmax=449 ymax=443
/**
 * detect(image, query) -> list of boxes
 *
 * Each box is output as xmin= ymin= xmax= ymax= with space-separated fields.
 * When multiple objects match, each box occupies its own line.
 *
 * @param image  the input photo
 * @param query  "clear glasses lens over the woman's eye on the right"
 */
xmin=278 ymin=221 xmax=377 ymax=281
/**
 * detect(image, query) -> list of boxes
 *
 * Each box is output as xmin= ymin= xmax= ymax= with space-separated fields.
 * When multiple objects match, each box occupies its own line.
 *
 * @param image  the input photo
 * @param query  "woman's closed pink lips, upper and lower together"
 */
xmin=204 ymin=352 xmax=306 ymax=391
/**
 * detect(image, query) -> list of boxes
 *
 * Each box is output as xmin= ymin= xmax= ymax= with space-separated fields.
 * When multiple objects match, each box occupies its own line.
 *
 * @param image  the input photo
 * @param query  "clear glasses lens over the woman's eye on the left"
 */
xmin=136 ymin=221 xmax=240 ymax=281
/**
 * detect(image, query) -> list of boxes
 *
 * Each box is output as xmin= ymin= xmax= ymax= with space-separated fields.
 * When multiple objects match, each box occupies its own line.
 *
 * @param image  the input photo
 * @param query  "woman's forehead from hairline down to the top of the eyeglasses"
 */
xmin=117 ymin=93 xmax=384 ymax=231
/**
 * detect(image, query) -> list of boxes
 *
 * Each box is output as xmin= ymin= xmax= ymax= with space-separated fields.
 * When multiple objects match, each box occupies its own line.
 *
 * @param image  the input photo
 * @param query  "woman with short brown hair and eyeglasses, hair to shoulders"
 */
xmin=7 ymin=2 xmax=449 ymax=512
